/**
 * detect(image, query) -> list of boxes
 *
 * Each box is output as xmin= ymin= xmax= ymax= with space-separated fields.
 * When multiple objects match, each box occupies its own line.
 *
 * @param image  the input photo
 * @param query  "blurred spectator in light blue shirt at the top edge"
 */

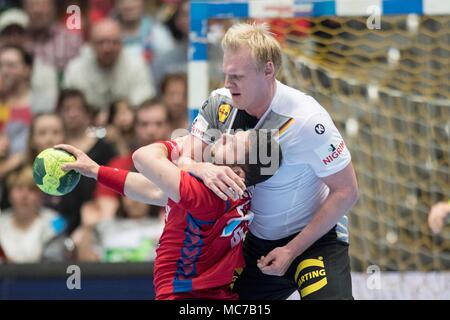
xmin=116 ymin=0 xmax=175 ymax=84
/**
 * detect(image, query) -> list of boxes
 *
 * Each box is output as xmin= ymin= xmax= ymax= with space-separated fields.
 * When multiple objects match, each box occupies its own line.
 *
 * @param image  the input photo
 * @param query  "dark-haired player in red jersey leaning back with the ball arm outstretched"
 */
xmin=56 ymin=130 xmax=281 ymax=299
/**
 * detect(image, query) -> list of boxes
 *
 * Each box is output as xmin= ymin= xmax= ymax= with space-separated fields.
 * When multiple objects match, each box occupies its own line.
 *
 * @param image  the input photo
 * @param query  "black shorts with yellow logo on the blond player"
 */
xmin=233 ymin=228 xmax=353 ymax=300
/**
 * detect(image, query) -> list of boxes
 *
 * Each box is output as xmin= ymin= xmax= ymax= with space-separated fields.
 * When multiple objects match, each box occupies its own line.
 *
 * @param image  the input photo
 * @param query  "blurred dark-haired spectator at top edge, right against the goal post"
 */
xmin=153 ymin=0 xmax=189 ymax=83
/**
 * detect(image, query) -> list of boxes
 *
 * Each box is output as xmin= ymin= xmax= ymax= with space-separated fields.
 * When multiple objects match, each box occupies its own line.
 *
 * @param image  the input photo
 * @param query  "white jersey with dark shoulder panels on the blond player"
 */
xmin=191 ymin=81 xmax=351 ymax=241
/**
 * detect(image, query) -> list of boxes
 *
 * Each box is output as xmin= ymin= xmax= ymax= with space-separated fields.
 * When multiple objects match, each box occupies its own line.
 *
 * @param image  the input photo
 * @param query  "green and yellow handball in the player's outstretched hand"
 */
xmin=33 ymin=148 xmax=80 ymax=196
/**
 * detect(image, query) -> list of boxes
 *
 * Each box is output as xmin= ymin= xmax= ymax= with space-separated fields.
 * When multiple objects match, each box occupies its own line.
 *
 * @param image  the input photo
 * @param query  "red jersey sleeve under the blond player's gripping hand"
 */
xmin=168 ymin=171 xmax=231 ymax=220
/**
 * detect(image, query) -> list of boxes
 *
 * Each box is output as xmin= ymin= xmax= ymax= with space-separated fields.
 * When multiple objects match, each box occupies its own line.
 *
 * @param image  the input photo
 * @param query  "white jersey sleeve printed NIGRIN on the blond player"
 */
xmin=282 ymin=112 xmax=351 ymax=178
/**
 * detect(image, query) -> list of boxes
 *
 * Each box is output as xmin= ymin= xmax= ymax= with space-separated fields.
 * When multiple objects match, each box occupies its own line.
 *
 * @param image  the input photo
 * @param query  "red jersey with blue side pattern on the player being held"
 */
xmin=154 ymin=171 xmax=251 ymax=300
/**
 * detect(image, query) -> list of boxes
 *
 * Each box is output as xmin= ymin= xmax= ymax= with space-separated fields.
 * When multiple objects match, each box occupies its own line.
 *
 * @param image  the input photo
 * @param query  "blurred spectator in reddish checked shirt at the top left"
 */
xmin=23 ymin=0 xmax=83 ymax=73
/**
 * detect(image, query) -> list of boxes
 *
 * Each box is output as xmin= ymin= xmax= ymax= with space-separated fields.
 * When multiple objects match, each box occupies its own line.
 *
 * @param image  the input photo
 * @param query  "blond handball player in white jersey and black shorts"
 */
xmin=185 ymin=24 xmax=358 ymax=299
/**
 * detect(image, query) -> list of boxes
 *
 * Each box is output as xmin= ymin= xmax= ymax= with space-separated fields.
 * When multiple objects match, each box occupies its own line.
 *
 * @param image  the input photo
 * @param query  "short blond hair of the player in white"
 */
xmin=222 ymin=23 xmax=281 ymax=72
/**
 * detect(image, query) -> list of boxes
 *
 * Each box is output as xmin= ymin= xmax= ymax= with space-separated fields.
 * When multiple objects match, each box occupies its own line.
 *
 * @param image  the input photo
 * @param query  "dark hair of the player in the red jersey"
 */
xmin=239 ymin=129 xmax=283 ymax=186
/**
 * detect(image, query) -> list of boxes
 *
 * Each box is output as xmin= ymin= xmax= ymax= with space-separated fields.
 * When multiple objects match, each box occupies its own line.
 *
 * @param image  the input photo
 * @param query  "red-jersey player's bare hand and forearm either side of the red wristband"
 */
xmin=55 ymin=144 xmax=167 ymax=206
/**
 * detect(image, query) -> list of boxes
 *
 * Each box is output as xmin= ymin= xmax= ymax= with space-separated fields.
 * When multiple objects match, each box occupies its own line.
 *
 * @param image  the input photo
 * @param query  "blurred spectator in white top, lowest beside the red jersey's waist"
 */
xmin=72 ymin=185 xmax=164 ymax=262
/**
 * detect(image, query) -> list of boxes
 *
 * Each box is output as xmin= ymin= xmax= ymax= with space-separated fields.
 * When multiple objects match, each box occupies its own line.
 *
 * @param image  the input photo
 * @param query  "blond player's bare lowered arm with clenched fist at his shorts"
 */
xmin=258 ymin=163 xmax=358 ymax=276
